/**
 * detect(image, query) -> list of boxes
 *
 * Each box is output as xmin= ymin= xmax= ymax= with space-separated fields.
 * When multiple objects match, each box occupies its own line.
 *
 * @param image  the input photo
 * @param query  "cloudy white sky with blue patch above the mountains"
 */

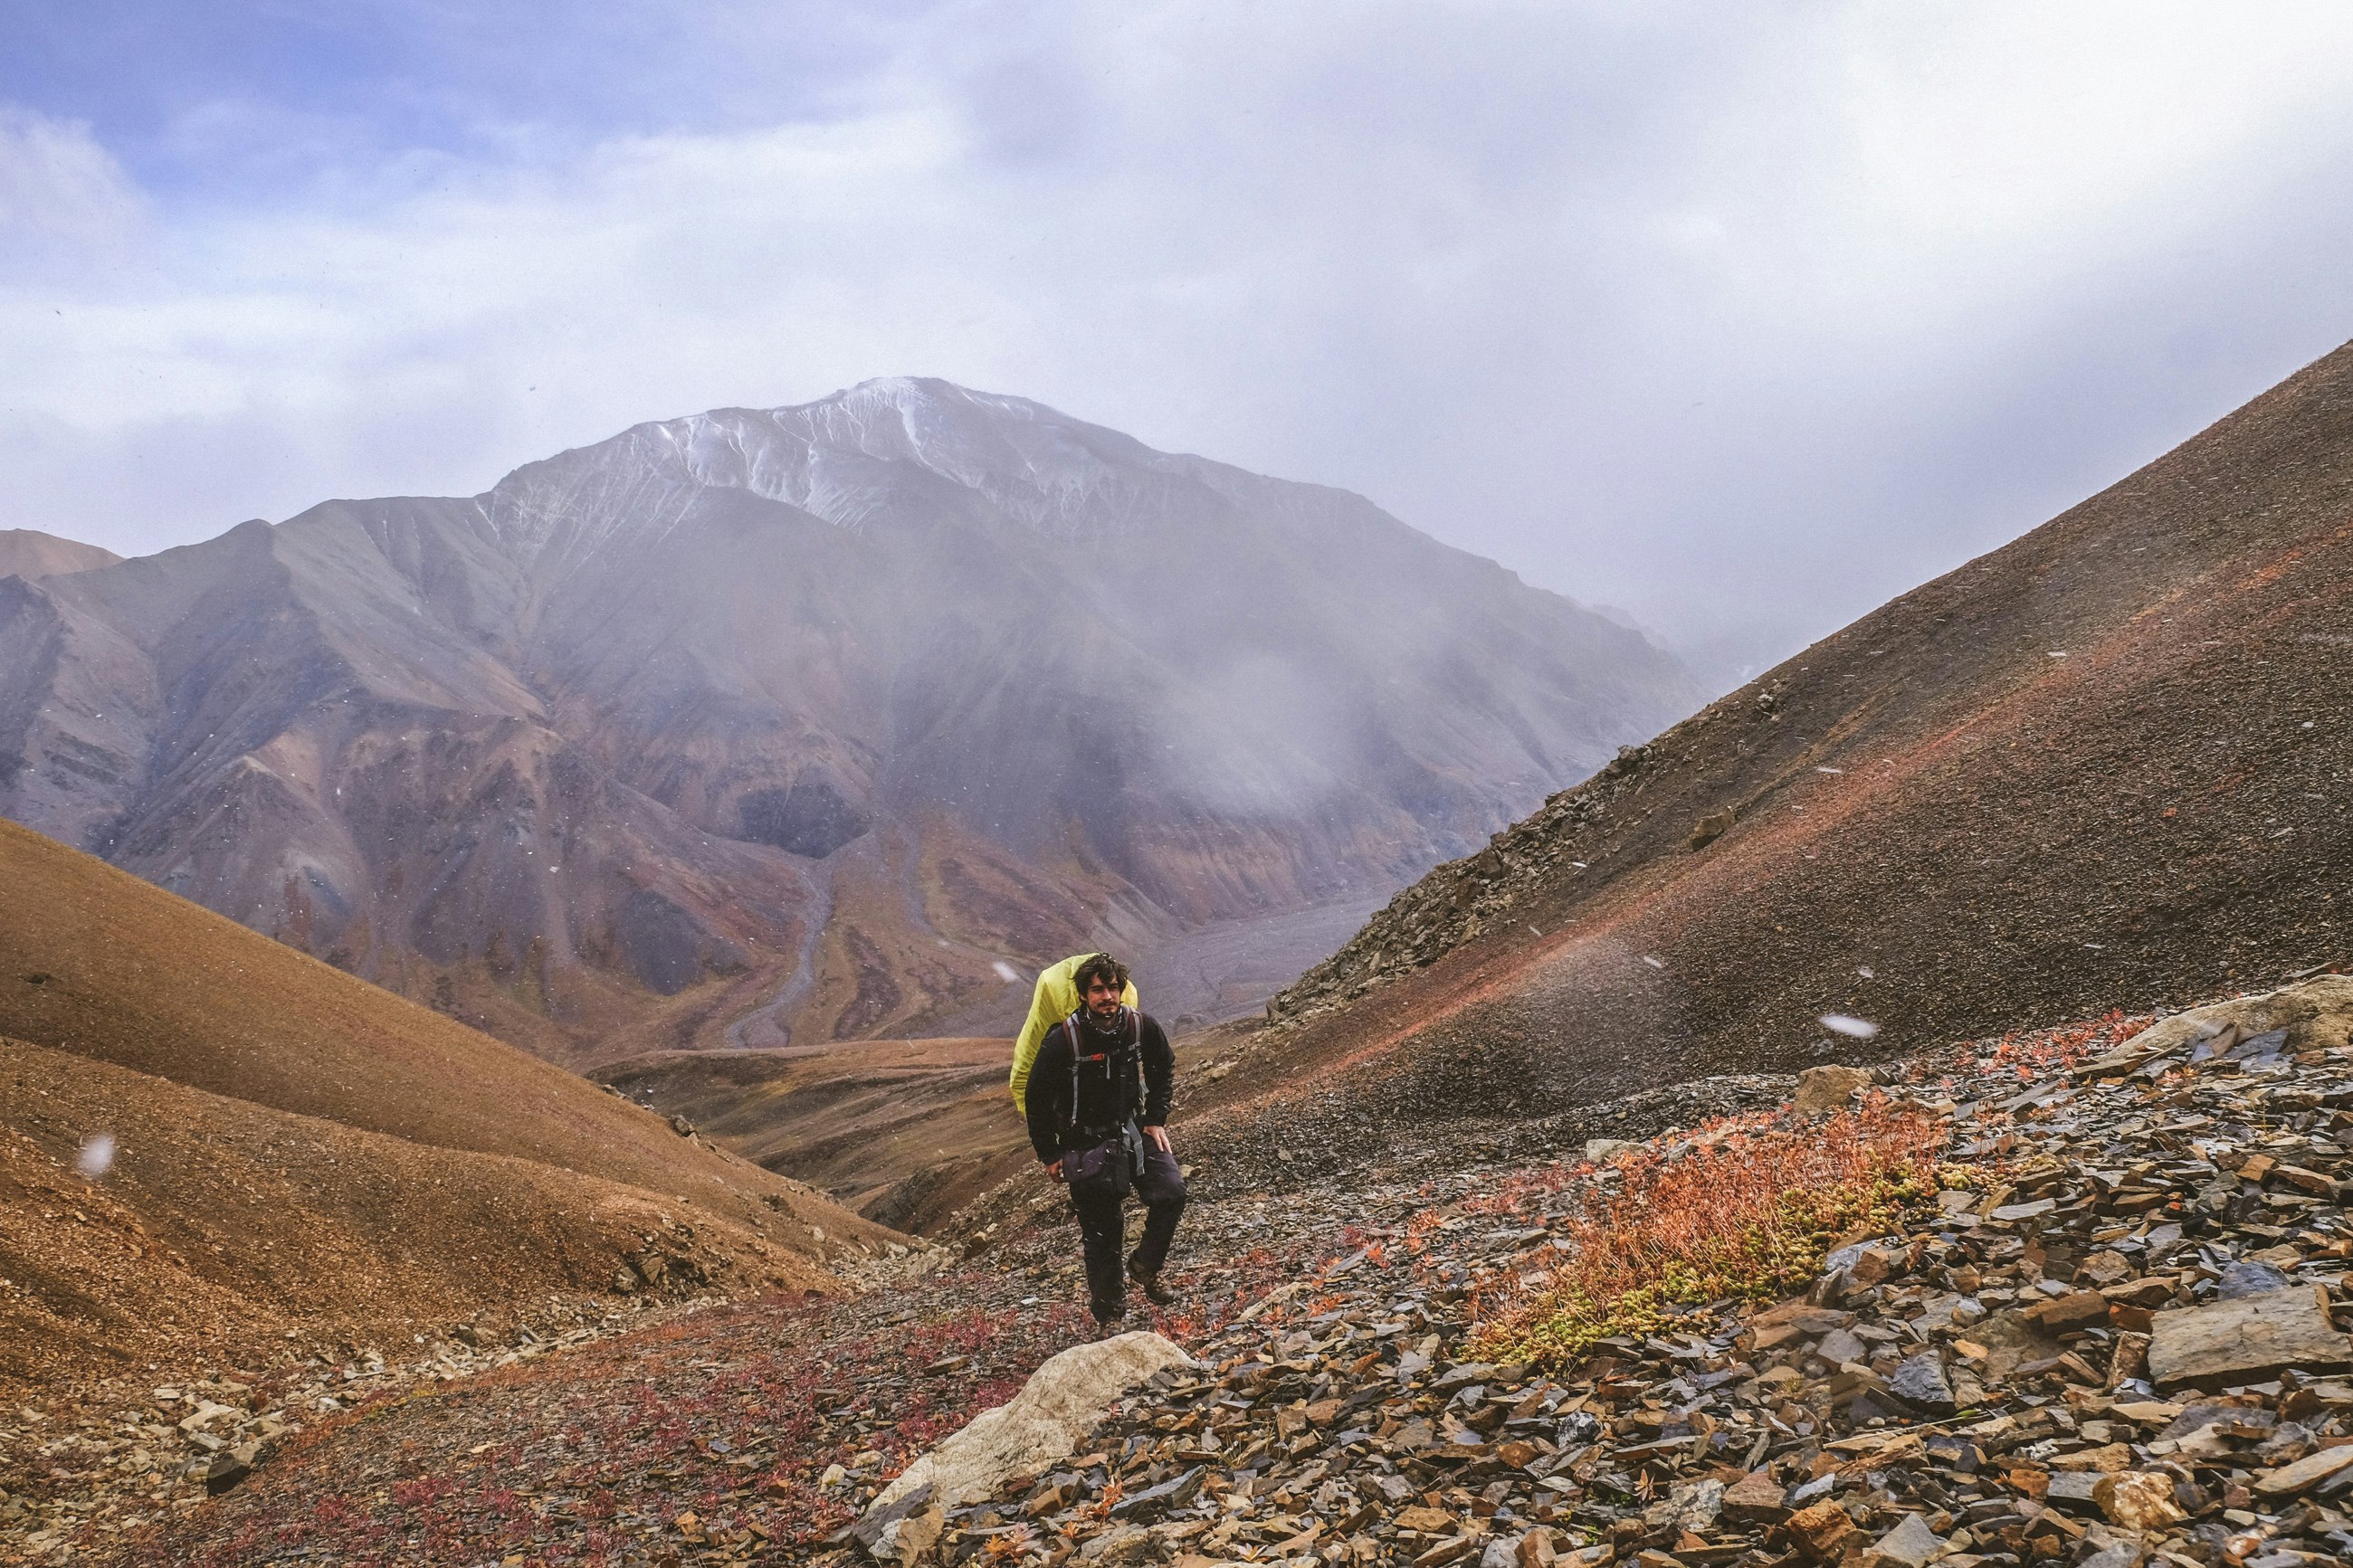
xmin=0 ymin=0 xmax=2353 ymax=687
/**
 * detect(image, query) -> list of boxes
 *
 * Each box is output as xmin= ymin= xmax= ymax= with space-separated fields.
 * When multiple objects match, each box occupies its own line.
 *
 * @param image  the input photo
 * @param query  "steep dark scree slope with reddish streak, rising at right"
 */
xmin=1219 ymin=348 xmax=2353 ymax=1117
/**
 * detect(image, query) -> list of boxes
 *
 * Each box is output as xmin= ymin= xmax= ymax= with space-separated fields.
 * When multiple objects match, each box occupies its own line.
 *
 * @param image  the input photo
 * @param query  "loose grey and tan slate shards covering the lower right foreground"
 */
xmin=840 ymin=983 xmax=2353 ymax=1568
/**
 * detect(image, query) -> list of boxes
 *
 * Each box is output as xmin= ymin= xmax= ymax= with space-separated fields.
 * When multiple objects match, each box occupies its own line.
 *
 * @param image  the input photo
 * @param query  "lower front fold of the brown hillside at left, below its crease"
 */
xmin=0 ymin=1039 xmax=828 ymax=1387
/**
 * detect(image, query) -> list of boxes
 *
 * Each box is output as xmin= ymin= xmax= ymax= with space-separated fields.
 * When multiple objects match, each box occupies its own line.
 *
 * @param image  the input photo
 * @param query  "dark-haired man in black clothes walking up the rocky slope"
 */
xmin=1024 ymin=952 xmax=1184 ymax=1326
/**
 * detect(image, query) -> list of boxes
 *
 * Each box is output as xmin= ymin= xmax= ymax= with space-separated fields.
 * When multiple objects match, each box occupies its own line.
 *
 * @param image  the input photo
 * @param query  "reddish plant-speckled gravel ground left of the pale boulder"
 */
xmin=0 ymin=1184 xmax=1344 ymax=1568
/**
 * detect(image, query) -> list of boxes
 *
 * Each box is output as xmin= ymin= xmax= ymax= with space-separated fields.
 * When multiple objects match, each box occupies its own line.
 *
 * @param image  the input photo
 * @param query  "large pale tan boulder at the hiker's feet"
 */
xmin=868 ymin=1331 xmax=1196 ymax=1516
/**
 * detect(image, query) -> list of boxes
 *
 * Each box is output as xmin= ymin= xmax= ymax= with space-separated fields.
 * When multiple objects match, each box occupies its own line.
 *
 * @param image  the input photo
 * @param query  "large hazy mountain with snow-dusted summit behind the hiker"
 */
xmin=0 ymin=381 xmax=1697 ymax=1062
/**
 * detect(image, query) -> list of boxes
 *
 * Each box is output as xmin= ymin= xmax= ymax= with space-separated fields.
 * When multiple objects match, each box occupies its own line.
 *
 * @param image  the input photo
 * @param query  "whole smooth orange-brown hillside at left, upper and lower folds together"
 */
xmin=0 ymin=822 xmax=887 ymax=1383
